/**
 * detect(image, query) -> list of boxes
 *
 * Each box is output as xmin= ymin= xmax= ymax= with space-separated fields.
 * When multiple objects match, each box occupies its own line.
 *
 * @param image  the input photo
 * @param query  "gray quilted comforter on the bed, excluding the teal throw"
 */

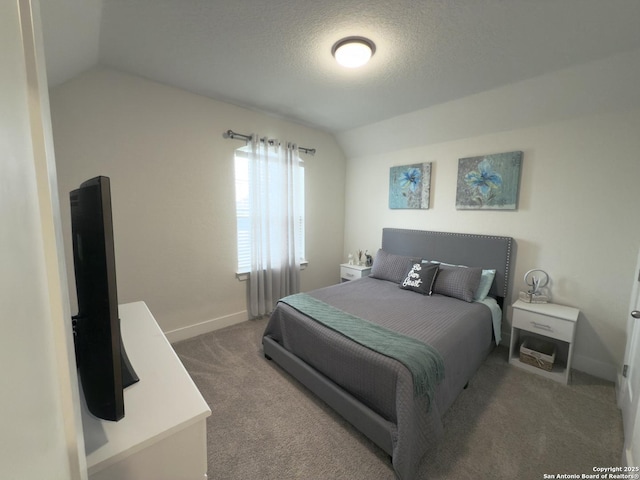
xmin=265 ymin=278 xmax=493 ymax=480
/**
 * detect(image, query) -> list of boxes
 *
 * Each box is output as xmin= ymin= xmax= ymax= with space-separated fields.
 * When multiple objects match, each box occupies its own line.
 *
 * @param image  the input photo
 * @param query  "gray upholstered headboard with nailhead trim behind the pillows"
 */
xmin=382 ymin=228 xmax=513 ymax=305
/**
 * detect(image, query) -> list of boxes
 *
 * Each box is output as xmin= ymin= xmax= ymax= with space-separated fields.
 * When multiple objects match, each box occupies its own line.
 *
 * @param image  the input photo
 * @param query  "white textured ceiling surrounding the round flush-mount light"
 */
xmin=43 ymin=0 xmax=640 ymax=132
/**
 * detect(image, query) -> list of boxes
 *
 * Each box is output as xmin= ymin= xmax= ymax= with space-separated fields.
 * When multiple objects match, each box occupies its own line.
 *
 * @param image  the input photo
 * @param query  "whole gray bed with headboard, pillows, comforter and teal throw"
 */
xmin=263 ymin=228 xmax=514 ymax=480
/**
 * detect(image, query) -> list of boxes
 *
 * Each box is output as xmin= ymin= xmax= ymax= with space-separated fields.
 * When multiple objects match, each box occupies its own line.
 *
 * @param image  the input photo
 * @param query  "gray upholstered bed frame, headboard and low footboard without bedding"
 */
xmin=263 ymin=228 xmax=514 ymax=456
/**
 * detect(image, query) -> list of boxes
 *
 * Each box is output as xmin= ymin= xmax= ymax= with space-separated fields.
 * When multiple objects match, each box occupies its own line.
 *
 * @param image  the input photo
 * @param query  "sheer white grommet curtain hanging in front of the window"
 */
xmin=249 ymin=135 xmax=304 ymax=318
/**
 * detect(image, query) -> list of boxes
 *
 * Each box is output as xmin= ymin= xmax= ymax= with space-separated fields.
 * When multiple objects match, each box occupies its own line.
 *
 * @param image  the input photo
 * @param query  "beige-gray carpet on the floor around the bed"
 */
xmin=174 ymin=320 xmax=623 ymax=480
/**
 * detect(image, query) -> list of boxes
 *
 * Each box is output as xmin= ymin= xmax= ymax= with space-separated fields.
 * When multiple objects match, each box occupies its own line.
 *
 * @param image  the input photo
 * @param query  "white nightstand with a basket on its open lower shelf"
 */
xmin=509 ymin=300 xmax=580 ymax=384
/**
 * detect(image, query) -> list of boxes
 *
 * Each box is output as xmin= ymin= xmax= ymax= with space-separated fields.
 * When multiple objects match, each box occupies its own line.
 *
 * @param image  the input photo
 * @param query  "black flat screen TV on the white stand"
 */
xmin=69 ymin=176 xmax=138 ymax=421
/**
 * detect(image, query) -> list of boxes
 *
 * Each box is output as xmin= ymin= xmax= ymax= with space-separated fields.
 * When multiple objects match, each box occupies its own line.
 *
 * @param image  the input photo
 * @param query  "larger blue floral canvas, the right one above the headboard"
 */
xmin=456 ymin=152 xmax=522 ymax=210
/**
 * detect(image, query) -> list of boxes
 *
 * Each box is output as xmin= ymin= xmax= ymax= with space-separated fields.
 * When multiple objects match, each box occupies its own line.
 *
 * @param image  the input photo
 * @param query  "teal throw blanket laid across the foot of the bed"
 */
xmin=280 ymin=293 xmax=444 ymax=402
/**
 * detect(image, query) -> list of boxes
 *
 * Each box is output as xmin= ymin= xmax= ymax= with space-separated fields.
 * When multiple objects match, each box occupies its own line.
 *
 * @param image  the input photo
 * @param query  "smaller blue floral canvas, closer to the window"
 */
xmin=389 ymin=162 xmax=431 ymax=209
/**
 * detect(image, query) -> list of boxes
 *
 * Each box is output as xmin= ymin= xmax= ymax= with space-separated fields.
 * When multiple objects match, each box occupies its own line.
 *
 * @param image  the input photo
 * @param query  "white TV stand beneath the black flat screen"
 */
xmin=80 ymin=302 xmax=211 ymax=480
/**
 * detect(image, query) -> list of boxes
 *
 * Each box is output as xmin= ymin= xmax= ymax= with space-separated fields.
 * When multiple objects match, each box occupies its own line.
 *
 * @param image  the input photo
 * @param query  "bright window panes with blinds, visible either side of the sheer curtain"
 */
xmin=234 ymin=147 xmax=305 ymax=273
